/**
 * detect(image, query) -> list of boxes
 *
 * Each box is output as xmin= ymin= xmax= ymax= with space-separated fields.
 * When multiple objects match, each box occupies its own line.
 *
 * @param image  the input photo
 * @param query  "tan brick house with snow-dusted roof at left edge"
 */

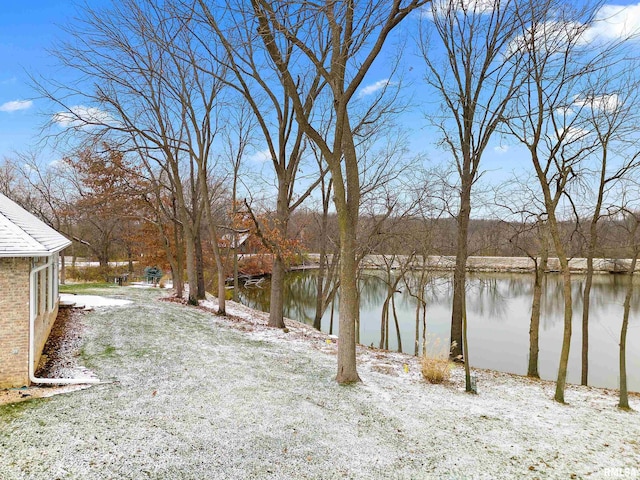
xmin=0 ymin=193 xmax=71 ymax=388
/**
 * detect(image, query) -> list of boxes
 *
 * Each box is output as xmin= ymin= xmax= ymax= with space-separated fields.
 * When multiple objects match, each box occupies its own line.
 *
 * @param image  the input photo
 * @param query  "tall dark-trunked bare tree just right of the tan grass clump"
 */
xmin=420 ymin=0 xmax=519 ymax=361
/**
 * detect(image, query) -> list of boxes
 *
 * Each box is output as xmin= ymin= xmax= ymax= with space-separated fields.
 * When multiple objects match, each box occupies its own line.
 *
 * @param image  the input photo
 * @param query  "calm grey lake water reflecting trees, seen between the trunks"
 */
xmin=240 ymin=271 xmax=640 ymax=392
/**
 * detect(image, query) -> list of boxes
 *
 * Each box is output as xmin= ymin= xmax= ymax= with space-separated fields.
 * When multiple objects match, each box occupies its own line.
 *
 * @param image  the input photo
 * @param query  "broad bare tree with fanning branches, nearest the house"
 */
xmin=40 ymin=0 xmax=224 ymax=306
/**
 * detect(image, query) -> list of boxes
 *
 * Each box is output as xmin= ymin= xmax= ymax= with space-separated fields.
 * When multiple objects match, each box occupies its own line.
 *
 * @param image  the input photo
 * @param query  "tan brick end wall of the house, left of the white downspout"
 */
xmin=0 ymin=258 xmax=30 ymax=388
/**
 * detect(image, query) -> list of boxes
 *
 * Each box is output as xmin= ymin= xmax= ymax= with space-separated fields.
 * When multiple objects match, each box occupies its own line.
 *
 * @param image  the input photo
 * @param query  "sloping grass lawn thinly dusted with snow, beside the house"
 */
xmin=0 ymin=288 xmax=640 ymax=480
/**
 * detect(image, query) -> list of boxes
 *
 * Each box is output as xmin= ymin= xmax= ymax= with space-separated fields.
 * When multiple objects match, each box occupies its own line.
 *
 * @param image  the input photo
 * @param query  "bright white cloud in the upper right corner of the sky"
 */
xmin=582 ymin=3 xmax=640 ymax=42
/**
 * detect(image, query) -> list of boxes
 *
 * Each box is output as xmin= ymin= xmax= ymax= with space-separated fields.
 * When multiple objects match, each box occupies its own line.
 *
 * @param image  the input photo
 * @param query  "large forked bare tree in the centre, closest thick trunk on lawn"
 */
xmin=251 ymin=0 xmax=427 ymax=383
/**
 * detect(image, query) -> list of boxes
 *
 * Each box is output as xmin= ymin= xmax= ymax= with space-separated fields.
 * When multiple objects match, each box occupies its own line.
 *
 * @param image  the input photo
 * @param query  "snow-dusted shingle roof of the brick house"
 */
xmin=0 ymin=193 xmax=71 ymax=257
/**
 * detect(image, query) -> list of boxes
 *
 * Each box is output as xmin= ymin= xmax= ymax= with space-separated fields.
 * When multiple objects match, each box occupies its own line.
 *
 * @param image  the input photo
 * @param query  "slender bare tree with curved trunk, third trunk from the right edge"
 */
xmin=505 ymin=0 xmax=624 ymax=402
